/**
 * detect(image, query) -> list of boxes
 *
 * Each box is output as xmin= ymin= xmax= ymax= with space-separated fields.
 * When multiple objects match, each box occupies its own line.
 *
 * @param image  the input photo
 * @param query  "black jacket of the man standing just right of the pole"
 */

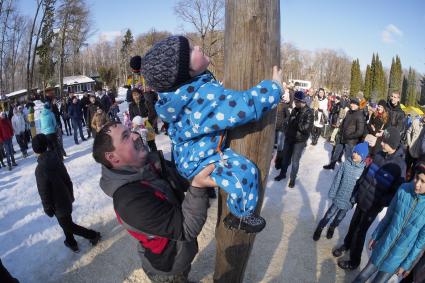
xmin=285 ymin=105 xmax=314 ymax=143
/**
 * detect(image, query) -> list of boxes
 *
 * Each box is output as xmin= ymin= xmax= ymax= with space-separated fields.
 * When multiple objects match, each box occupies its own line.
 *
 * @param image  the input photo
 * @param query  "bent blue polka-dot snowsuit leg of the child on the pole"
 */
xmin=211 ymin=149 xmax=258 ymax=218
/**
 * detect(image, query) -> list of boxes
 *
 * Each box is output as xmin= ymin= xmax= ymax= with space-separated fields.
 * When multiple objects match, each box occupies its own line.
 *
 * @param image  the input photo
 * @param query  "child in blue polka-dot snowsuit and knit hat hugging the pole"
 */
xmin=135 ymin=36 xmax=282 ymax=233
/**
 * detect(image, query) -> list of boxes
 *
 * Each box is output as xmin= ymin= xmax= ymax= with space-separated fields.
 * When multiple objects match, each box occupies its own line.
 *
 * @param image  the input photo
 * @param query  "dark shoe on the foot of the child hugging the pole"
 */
xmin=223 ymin=213 xmax=266 ymax=233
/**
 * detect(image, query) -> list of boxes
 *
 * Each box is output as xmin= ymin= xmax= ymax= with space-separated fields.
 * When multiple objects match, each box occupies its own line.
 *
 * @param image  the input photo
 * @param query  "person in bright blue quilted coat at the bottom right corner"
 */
xmin=354 ymin=162 xmax=425 ymax=283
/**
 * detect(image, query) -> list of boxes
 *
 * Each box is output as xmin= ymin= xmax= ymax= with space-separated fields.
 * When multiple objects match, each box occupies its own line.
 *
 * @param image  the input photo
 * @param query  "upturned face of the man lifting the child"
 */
xmin=106 ymin=124 xmax=148 ymax=168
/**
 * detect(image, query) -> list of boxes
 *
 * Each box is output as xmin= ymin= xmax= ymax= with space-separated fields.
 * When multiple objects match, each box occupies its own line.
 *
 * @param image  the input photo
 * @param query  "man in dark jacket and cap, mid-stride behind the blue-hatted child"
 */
xmin=323 ymin=98 xmax=366 ymax=169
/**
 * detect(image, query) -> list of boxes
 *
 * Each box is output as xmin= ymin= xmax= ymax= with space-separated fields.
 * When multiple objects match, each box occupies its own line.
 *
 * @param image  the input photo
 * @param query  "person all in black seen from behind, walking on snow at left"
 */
xmin=32 ymin=134 xmax=101 ymax=252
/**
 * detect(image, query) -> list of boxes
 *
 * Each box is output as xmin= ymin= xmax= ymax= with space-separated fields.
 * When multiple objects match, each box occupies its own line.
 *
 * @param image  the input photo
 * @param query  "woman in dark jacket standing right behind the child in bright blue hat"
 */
xmin=366 ymin=99 xmax=389 ymax=158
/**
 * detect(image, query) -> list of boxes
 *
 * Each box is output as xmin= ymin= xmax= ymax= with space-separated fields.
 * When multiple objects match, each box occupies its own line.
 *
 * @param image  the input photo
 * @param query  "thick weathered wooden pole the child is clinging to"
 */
xmin=214 ymin=0 xmax=280 ymax=283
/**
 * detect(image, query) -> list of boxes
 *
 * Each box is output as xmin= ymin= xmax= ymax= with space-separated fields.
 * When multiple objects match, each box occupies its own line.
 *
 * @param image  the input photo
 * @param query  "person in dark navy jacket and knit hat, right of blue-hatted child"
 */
xmin=332 ymin=127 xmax=406 ymax=270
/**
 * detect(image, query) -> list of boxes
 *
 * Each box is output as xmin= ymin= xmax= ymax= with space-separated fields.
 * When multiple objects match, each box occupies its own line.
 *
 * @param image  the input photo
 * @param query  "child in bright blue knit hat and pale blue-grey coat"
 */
xmin=313 ymin=142 xmax=369 ymax=241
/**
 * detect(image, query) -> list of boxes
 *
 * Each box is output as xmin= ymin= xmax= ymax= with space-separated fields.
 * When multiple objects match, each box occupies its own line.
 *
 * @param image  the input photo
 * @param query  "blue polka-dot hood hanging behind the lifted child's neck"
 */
xmin=155 ymin=73 xmax=214 ymax=123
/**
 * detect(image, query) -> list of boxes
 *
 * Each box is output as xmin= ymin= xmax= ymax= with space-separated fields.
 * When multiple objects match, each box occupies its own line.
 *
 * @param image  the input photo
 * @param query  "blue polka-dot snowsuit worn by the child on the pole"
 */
xmin=155 ymin=73 xmax=281 ymax=217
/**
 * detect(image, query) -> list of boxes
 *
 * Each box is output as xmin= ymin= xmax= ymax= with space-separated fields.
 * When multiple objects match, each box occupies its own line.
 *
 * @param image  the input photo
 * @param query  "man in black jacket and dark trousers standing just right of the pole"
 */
xmin=274 ymin=91 xmax=314 ymax=188
